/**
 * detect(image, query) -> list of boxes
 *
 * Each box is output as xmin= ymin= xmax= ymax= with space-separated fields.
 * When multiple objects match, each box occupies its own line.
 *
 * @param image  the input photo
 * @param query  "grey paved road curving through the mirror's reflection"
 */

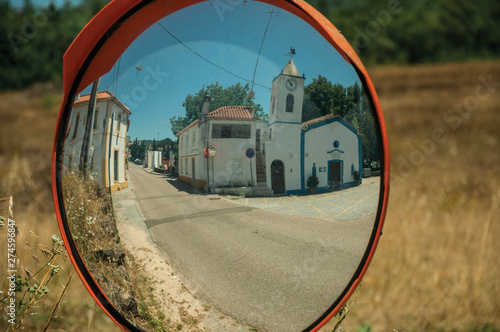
xmin=129 ymin=166 xmax=374 ymax=332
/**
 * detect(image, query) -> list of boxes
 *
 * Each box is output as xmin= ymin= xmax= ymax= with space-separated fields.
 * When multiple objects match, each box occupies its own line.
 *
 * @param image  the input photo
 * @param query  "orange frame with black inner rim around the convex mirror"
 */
xmin=52 ymin=0 xmax=390 ymax=331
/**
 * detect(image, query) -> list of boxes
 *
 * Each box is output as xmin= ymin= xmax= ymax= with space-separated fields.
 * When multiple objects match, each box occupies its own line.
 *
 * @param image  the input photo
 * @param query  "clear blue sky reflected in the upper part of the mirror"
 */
xmin=78 ymin=1 xmax=359 ymax=139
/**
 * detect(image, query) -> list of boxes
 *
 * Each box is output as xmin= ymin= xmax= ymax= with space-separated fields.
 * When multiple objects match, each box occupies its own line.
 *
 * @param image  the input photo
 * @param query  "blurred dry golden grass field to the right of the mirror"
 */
xmin=324 ymin=62 xmax=500 ymax=331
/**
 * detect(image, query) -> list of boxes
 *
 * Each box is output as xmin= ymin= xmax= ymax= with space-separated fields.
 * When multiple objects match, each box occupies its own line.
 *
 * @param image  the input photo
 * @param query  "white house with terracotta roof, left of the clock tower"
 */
xmin=177 ymin=96 xmax=267 ymax=192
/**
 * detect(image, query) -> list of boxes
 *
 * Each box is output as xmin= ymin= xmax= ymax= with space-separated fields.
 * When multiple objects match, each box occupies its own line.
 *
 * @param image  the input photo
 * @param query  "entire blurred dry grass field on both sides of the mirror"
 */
xmin=0 ymin=62 xmax=500 ymax=332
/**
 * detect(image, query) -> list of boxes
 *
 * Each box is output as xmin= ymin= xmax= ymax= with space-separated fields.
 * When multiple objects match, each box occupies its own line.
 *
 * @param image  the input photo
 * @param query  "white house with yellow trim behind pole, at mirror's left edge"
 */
xmin=63 ymin=91 xmax=131 ymax=191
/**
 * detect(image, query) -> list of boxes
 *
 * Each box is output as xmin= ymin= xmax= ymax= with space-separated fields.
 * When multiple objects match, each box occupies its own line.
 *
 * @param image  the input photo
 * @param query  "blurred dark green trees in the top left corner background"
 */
xmin=0 ymin=0 xmax=109 ymax=91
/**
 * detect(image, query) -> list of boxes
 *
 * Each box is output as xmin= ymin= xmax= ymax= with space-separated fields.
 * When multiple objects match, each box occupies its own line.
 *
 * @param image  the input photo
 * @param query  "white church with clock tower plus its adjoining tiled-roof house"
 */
xmin=178 ymin=59 xmax=362 ymax=196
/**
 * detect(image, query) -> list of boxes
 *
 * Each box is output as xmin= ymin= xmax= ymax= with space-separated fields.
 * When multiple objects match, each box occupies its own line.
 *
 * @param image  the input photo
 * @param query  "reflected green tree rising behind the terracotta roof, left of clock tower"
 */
xmin=170 ymin=82 xmax=267 ymax=135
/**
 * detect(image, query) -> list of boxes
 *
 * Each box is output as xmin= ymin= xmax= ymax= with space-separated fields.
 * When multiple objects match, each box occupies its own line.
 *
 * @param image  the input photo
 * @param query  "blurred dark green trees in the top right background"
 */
xmin=316 ymin=0 xmax=500 ymax=65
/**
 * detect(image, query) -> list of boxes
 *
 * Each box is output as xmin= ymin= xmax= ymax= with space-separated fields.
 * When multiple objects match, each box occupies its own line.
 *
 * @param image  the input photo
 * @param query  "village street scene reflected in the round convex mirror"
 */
xmin=62 ymin=1 xmax=382 ymax=331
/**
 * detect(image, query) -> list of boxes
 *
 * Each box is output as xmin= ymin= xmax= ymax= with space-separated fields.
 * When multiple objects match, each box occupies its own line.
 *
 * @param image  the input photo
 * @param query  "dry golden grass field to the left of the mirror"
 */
xmin=0 ymin=85 xmax=121 ymax=332
